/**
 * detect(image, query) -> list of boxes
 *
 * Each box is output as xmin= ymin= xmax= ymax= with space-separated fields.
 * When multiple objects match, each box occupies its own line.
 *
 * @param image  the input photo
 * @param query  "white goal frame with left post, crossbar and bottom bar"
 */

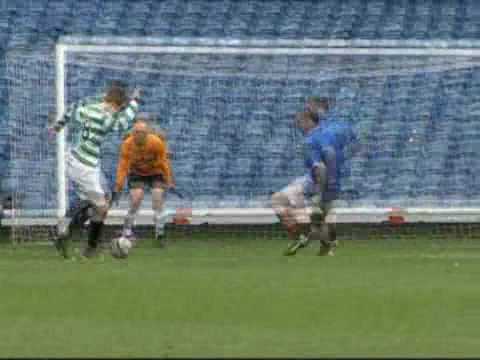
xmin=6 ymin=36 xmax=480 ymax=228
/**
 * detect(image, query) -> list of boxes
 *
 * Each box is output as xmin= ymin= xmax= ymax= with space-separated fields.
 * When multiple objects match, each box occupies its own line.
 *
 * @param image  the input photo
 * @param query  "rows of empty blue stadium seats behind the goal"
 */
xmin=0 ymin=0 xmax=480 ymax=210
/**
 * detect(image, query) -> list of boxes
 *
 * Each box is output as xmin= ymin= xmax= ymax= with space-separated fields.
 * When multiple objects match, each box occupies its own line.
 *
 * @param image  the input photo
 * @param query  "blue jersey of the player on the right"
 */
xmin=305 ymin=112 xmax=357 ymax=194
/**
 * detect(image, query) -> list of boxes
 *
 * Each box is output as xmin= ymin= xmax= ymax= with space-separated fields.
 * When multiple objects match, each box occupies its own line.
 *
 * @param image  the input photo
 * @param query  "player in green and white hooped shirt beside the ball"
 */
xmin=53 ymin=85 xmax=140 ymax=257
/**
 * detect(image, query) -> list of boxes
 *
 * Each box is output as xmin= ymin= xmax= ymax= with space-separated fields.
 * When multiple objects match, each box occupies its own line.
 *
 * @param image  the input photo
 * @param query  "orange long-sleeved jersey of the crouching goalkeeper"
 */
xmin=115 ymin=133 xmax=173 ymax=192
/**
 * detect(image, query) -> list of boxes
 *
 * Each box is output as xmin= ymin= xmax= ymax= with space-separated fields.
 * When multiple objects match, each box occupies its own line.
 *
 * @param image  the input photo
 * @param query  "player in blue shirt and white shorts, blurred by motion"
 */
xmin=272 ymin=99 xmax=356 ymax=255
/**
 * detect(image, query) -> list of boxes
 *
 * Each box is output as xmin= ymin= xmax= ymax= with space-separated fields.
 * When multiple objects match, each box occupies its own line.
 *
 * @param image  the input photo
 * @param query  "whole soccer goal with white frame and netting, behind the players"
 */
xmin=5 ymin=37 xmax=480 ymax=242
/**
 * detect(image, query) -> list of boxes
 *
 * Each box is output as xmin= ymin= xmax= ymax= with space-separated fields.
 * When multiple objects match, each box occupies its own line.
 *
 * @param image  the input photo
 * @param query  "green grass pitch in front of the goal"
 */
xmin=0 ymin=236 xmax=480 ymax=357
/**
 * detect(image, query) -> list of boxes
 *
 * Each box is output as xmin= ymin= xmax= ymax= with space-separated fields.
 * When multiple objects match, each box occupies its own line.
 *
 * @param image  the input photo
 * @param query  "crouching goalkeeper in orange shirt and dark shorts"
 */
xmin=112 ymin=115 xmax=174 ymax=246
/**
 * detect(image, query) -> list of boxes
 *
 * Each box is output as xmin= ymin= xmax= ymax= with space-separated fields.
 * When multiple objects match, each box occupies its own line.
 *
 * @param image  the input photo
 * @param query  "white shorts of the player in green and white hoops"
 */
xmin=67 ymin=153 xmax=107 ymax=207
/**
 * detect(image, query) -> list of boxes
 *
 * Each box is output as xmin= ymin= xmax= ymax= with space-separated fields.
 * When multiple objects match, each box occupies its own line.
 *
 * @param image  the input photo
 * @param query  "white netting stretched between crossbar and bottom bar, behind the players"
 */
xmin=62 ymin=47 xmax=480 ymax=207
